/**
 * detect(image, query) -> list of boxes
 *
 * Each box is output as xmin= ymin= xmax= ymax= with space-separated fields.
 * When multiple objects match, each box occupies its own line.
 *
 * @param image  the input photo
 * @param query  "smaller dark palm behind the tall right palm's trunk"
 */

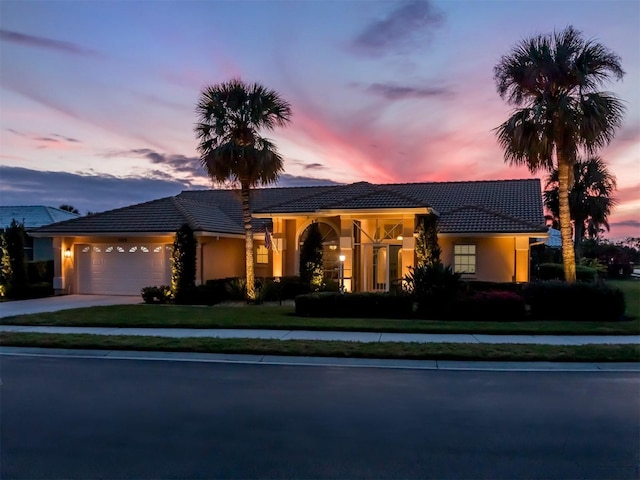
xmin=543 ymin=156 xmax=617 ymax=260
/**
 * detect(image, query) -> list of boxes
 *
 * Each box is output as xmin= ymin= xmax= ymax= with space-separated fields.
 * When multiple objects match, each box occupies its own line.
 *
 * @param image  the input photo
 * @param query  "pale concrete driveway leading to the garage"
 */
xmin=0 ymin=295 xmax=142 ymax=318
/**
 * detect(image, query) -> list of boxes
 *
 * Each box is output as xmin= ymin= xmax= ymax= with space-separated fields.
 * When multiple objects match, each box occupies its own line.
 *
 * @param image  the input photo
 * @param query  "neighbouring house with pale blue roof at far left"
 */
xmin=0 ymin=205 xmax=78 ymax=260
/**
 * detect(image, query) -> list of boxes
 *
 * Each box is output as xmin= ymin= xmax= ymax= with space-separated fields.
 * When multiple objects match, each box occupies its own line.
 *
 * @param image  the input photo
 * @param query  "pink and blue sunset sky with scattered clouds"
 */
xmin=0 ymin=0 xmax=640 ymax=240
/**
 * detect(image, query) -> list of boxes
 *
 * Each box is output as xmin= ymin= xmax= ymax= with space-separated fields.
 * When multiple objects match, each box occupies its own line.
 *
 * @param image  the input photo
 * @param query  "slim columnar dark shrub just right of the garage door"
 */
xmin=171 ymin=223 xmax=198 ymax=303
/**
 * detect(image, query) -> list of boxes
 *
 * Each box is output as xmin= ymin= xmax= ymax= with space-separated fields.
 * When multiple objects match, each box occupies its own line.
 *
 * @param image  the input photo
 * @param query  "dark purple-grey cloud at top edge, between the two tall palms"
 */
xmin=349 ymin=0 xmax=444 ymax=56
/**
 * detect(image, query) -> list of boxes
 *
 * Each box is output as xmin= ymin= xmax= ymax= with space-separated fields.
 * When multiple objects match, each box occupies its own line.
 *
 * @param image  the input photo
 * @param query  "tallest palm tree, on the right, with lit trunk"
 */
xmin=494 ymin=26 xmax=624 ymax=282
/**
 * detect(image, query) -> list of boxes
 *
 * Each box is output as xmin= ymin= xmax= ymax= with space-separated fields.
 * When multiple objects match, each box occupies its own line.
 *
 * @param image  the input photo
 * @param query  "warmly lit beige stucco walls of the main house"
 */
xmin=48 ymin=210 xmax=540 ymax=293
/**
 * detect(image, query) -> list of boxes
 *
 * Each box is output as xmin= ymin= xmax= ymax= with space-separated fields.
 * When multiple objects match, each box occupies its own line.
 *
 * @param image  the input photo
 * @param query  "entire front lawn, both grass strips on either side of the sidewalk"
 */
xmin=0 ymin=280 xmax=640 ymax=362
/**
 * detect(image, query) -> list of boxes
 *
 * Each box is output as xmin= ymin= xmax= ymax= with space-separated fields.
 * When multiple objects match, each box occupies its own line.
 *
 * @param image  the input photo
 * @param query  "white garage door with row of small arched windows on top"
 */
xmin=76 ymin=243 xmax=172 ymax=295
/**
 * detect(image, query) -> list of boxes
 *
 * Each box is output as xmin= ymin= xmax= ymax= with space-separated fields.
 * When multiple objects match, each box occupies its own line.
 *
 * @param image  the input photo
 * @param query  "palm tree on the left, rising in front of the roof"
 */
xmin=195 ymin=78 xmax=291 ymax=301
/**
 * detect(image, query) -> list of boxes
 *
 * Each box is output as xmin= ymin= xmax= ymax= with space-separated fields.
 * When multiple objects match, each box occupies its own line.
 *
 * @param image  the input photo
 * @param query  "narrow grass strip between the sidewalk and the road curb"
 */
xmin=0 ymin=332 xmax=640 ymax=362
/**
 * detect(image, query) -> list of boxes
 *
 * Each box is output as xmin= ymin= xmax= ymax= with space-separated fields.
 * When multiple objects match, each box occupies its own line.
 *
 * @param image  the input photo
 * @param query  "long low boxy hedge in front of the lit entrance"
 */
xmin=295 ymin=292 xmax=413 ymax=318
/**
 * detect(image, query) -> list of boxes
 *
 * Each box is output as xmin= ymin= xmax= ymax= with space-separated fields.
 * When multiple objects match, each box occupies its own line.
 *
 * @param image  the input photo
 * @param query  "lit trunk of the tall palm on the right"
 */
xmin=556 ymin=155 xmax=576 ymax=283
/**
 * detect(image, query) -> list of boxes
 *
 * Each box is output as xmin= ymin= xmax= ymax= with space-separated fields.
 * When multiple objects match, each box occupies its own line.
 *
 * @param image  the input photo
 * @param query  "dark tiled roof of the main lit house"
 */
xmin=32 ymin=179 xmax=546 ymax=236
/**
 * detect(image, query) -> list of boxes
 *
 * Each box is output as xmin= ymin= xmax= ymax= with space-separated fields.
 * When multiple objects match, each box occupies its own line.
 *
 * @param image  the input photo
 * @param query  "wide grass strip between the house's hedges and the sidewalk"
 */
xmin=0 ymin=305 xmax=640 ymax=335
